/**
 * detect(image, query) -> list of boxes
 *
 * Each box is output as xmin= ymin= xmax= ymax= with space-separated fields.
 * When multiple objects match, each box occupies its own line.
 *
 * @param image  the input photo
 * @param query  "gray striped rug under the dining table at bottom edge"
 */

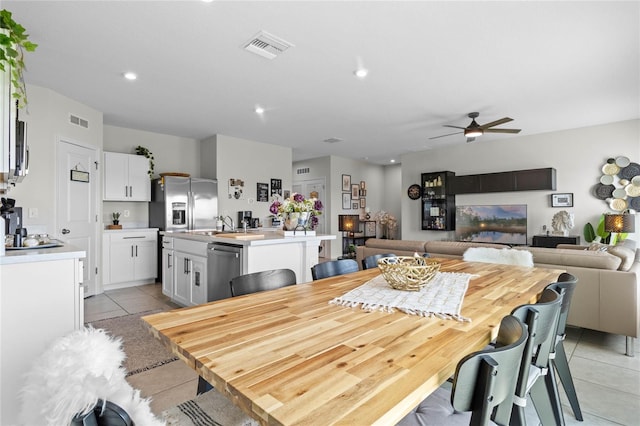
xmin=162 ymin=389 xmax=259 ymax=426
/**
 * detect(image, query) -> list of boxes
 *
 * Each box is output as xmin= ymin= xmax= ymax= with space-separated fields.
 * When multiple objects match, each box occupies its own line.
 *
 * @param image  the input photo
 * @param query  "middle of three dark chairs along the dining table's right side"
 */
xmin=496 ymin=289 xmax=564 ymax=426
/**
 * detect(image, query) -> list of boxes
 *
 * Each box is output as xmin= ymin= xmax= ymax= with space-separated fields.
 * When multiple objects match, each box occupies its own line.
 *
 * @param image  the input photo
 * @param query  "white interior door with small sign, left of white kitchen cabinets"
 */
xmin=55 ymin=140 xmax=100 ymax=296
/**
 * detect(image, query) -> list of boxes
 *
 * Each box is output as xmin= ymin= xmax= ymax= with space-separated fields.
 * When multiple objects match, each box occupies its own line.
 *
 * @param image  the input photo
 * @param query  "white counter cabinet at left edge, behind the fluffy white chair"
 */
xmin=0 ymin=246 xmax=86 ymax=425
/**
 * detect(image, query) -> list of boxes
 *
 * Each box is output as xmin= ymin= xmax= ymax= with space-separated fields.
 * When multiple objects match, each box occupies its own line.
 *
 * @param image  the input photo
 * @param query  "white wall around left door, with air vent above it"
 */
xmin=4 ymin=85 xmax=103 ymax=235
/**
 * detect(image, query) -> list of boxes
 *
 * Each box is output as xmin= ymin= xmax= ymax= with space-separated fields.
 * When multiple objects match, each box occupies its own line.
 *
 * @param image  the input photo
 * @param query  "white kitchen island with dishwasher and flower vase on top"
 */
xmin=161 ymin=230 xmax=336 ymax=306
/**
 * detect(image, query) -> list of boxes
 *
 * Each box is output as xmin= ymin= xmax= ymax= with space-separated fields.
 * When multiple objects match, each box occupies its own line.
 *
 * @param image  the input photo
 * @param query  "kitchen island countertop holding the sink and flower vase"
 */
xmin=160 ymin=229 xmax=336 ymax=246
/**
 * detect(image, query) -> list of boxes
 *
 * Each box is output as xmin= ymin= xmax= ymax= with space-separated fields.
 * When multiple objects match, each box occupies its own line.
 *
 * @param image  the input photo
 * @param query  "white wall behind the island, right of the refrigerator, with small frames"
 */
xmin=216 ymin=135 xmax=292 ymax=225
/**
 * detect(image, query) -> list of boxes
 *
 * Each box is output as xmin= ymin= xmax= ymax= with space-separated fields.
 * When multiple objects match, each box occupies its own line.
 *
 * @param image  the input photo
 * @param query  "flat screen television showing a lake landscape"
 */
xmin=456 ymin=204 xmax=527 ymax=245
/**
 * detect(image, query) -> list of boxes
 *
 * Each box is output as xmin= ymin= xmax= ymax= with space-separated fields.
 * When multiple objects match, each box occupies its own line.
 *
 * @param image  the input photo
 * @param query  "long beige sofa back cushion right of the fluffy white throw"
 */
xmin=515 ymin=247 xmax=622 ymax=271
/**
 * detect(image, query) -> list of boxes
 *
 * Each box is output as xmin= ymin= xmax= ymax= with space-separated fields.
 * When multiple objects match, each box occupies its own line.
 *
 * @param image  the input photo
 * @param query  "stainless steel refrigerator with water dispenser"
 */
xmin=149 ymin=176 xmax=218 ymax=232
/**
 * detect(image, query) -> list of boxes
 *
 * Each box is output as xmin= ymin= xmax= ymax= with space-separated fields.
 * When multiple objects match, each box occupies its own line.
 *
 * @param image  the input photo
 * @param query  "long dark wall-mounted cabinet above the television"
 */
xmin=449 ymin=167 xmax=556 ymax=194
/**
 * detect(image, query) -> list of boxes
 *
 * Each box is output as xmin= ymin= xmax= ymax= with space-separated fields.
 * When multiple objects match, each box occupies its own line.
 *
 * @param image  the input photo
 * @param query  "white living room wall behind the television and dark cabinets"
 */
xmin=402 ymin=120 xmax=640 ymax=242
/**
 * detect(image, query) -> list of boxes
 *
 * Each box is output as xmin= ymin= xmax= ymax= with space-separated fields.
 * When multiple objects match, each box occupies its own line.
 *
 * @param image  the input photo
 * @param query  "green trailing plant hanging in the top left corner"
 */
xmin=0 ymin=9 xmax=38 ymax=108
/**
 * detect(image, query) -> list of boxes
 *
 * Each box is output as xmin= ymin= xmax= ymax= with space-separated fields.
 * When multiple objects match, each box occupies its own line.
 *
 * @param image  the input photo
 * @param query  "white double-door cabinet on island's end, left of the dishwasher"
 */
xmin=172 ymin=239 xmax=207 ymax=306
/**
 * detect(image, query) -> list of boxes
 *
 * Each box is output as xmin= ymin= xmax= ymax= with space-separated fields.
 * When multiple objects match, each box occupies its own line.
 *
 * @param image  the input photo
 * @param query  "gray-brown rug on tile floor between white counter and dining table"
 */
xmin=91 ymin=311 xmax=178 ymax=377
